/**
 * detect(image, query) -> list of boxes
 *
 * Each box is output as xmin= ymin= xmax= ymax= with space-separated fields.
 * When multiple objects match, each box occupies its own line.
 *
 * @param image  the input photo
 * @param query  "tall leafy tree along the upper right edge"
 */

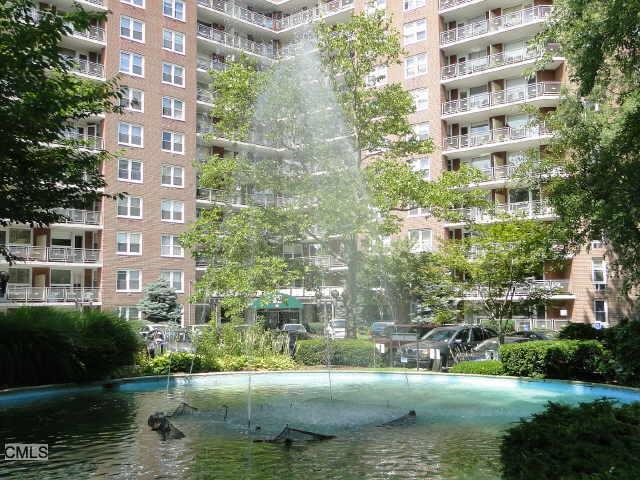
xmin=528 ymin=0 xmax=640 ymax=287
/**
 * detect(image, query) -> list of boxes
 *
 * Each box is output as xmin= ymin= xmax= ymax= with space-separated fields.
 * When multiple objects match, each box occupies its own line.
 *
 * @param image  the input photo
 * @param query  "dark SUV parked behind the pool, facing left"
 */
xmin=397 ymin=325 xmax=498 ymax=368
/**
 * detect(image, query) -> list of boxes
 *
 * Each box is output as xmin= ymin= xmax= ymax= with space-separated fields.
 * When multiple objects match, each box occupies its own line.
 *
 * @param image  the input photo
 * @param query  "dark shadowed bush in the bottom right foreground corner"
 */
xmin=500 ymin=400 xmax=640 ymax=480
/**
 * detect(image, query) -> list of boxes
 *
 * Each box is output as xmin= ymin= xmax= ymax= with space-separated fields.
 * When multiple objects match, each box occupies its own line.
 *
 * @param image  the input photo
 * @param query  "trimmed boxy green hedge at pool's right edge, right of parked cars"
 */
xmin=500 ymin=340 xmax=610 ymax=381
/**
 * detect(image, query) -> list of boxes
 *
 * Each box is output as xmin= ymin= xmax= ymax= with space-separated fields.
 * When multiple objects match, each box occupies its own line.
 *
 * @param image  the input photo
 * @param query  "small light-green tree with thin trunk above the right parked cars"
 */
xmin=437 ymin=218 xmax=563 ymax=341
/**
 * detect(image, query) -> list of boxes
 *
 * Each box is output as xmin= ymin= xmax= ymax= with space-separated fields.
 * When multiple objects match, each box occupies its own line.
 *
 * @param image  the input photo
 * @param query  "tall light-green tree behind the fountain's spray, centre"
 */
xmin=183 ymin=13 xmax=482 ymax=334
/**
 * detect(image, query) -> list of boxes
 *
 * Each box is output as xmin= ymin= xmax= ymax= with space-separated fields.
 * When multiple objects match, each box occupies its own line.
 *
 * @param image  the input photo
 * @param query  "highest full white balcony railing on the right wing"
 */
xmin=440 ymin=5 xmax=553 ymax=46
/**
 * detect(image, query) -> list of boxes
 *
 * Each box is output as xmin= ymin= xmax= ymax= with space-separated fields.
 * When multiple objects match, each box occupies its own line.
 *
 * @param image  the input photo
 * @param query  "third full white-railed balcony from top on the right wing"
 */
xmin=442 ymin=82 xmax=562 ymax=119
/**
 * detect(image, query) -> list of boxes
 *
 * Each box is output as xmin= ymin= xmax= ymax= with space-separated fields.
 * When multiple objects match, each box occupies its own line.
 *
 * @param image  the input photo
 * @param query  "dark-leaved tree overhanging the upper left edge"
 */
xmin=0 ymin=0 xmax=119 ymax=246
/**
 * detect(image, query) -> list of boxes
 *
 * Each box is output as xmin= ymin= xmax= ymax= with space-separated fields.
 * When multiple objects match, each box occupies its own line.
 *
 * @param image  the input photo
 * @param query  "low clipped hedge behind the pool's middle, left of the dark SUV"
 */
xmin=295 ymin=338 xmax=382 ymax=367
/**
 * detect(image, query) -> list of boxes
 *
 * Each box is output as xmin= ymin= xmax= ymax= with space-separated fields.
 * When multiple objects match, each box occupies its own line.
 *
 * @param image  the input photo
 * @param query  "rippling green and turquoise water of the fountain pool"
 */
xmin=0 ymin=372 xmax=640 ymax=480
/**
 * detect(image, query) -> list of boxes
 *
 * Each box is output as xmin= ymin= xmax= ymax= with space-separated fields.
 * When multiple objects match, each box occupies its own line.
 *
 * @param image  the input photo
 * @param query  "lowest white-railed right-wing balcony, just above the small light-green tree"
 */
xmin=445 ymin=200 xmax=555 ymax=226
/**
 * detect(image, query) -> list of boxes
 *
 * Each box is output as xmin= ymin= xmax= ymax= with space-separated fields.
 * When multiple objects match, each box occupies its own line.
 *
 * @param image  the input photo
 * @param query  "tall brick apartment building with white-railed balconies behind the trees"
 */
xmin=0 ymin=0 xmax=625 ymax=328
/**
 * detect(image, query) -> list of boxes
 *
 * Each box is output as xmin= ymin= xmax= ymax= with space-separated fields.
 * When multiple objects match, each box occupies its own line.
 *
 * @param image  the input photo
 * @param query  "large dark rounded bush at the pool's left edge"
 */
xmin=0 ymin=307 xmax=141 ymax=387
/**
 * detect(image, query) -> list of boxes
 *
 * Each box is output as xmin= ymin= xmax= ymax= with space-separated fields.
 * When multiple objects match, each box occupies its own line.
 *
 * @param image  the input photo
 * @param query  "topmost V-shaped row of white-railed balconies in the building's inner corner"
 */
xmin=198 ymin=0 xmax=354 ymax=32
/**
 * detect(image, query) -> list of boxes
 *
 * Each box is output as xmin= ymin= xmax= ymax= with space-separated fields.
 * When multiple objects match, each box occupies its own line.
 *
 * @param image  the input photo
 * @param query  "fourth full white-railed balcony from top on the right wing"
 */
xmin=442 ymin=124 xmax=551 ymax=157
